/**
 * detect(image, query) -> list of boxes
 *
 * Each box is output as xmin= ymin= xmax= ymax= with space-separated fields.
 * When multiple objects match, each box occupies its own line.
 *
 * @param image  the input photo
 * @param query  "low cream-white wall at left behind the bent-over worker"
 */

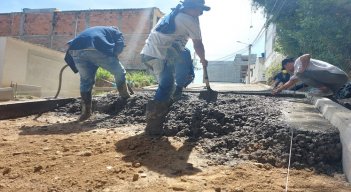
xmin=0 ymin=37 xmax=79 ymax=97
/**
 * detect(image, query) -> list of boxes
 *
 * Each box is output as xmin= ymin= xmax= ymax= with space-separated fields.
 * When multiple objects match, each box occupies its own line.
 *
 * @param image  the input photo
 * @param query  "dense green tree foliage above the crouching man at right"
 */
xmin=252 ymin=0 xmax=351 ymax=73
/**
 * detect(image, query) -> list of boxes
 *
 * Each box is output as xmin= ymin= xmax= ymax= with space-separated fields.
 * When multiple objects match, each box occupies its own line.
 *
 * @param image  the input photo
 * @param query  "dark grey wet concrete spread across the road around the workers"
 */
xmin=56 ymin=91 xmax=342 ymax=174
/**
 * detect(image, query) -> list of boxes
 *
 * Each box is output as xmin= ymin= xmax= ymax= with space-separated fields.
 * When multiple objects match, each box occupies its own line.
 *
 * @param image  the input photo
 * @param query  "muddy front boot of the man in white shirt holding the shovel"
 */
xmin=145 ymin=100 xmax=169 ymax=137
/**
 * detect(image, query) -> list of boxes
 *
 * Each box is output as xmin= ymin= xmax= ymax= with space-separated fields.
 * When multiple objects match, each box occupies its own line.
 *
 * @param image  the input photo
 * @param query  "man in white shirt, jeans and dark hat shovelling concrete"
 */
xmin=141 ymin=0 xmax=210 ymax=136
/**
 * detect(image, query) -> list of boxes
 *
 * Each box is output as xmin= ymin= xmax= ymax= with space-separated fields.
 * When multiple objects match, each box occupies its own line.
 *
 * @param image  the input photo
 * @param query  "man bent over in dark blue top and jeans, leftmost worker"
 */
xmin=65 ymin=26 xmax=130 ymax=121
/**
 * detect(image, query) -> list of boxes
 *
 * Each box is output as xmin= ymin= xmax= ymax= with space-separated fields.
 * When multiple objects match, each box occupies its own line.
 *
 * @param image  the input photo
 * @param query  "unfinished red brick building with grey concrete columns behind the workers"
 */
xmin=0 ymin=7 xmax=163 ymax=69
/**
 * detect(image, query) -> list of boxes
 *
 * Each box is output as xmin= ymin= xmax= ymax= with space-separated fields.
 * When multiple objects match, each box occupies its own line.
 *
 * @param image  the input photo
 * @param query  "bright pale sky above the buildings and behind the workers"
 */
xmin=0 ymin=0 xmax=265 ymax=60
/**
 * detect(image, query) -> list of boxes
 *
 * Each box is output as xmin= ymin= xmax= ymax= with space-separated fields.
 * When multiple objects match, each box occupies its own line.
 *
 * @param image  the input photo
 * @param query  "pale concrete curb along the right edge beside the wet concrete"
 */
xmin=308 ymin=96 xmax=351 ymax=182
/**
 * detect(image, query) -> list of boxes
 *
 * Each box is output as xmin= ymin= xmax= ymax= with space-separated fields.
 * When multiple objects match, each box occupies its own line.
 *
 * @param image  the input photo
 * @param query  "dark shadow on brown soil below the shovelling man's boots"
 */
xmin=116 ymin=134 xmax=201 ymax=177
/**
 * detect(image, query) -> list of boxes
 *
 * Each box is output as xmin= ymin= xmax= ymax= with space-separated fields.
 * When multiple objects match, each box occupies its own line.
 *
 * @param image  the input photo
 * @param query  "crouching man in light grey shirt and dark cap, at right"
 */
xmin=273 ymin=54 xmax=351 ymax=99
